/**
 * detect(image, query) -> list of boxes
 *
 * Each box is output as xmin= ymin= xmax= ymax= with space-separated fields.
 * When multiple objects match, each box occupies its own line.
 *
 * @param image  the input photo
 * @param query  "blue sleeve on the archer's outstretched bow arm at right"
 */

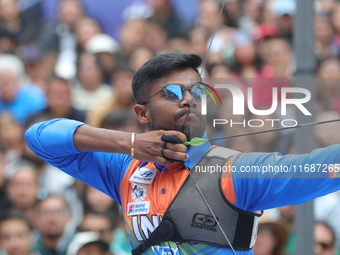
xmin=233 ymin=144 xmax=340 ymax=211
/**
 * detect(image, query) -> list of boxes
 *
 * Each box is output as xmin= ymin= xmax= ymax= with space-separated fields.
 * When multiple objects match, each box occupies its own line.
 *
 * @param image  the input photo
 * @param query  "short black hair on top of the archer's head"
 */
xmin=132 ymin=52 xmax=202 ymax=104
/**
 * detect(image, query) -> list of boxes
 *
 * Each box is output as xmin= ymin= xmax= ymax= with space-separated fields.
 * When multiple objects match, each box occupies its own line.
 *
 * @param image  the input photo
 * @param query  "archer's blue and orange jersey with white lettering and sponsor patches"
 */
xmin=26 ymin=119 xmax=340 ymax=255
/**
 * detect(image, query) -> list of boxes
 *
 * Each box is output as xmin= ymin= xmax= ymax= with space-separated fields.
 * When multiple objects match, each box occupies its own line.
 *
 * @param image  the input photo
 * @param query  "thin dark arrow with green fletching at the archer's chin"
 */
xmin=183 ymin=119 xmax=340 ymax=146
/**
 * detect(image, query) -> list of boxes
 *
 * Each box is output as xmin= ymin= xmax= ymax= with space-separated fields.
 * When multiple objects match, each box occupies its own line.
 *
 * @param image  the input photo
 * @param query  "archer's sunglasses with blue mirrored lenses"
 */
xmin=141 ymin=83 xmax=210 ymax=105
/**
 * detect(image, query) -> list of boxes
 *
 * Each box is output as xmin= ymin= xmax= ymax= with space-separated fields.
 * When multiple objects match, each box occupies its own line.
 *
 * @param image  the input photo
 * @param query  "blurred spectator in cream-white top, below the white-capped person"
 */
xmin=72 ymin=52 xmax=113 ymax=112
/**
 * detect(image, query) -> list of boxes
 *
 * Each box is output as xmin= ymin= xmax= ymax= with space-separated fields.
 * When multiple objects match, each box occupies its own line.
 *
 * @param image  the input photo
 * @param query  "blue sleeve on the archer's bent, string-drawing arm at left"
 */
xmin=25 ymin=119 xmax=131 ymax=204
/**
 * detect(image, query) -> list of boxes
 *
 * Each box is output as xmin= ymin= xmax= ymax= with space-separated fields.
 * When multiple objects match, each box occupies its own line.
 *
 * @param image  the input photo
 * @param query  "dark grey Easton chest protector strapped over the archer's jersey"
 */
xmin=132 ymin=147 xmax=261 ymax=255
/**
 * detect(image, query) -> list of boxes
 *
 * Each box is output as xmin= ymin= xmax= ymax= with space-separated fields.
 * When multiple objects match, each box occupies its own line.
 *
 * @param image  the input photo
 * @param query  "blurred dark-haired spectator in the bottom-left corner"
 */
xmin=0 ymin=211 xmax=41 ymax=255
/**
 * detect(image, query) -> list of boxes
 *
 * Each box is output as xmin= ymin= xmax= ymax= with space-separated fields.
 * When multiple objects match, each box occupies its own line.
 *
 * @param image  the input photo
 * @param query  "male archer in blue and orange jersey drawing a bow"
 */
xmin=26 ymin=53 xmax=340 ymax=255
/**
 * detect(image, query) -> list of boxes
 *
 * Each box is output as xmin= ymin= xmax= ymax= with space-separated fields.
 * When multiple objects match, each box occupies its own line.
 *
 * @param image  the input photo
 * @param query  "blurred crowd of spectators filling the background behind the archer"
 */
xmin=0 ymin=0 xmax=340 ymax=255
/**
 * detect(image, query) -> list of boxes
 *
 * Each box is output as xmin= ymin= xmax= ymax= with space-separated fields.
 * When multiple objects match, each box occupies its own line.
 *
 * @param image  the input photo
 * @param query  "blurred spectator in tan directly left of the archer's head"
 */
xmin=87 ymin=68 xmax=134 ymax=127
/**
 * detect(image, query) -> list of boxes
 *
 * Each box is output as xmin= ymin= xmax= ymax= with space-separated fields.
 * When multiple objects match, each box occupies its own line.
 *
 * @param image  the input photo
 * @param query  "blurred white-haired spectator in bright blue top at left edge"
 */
xmin=0 ymin=55 xmax=46 ymax=124
